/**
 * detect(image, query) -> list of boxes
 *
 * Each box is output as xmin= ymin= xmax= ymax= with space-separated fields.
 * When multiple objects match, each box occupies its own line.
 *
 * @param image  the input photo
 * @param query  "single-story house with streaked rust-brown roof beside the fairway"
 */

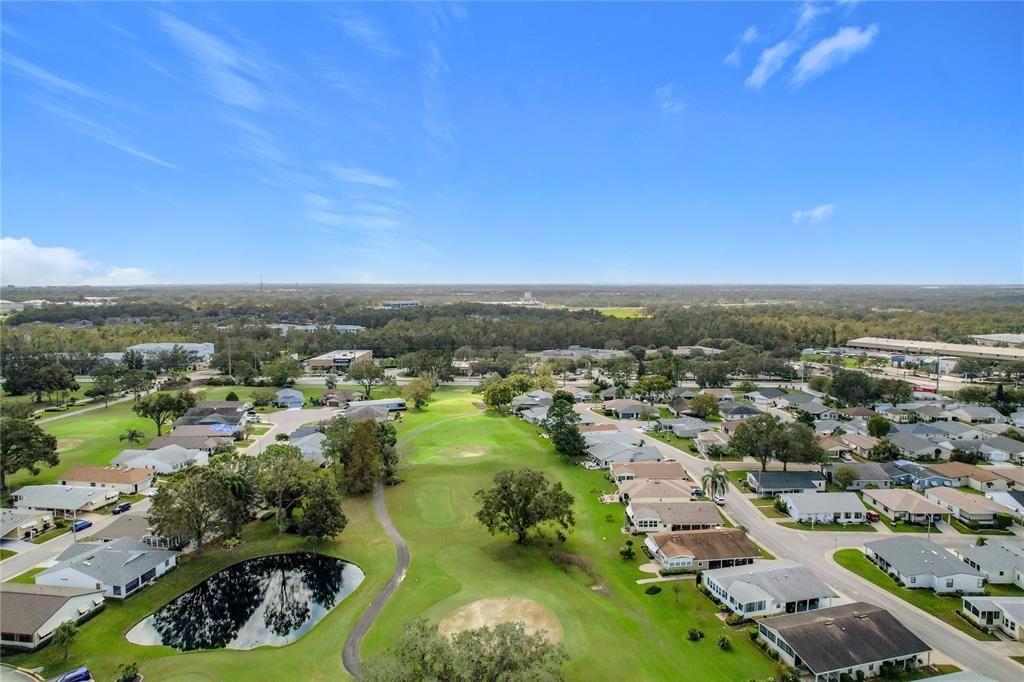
xmin=644 ymin=528 xmax=761 ymax=570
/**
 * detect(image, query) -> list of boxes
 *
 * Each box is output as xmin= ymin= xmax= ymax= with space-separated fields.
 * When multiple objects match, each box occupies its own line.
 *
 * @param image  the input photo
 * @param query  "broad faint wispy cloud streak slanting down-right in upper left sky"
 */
xmin=158 ymin=12 xmax=266 ymax=111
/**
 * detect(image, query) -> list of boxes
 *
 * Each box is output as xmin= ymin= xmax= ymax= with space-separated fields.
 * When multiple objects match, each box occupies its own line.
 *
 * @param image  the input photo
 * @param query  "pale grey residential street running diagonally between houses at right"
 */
xmin=583 ymin=406 xmax=1024 ymax=682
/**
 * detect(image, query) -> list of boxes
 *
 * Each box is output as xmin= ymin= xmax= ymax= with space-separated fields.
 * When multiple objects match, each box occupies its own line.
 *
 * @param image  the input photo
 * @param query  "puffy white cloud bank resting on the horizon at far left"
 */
xmin=0 ymin=237 xmax=156 ymax=287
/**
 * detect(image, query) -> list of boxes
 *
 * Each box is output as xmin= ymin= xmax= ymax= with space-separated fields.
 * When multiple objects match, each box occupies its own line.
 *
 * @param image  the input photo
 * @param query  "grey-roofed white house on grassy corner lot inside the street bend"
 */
xmin=864 ymin=538 xmax=985 ymax=594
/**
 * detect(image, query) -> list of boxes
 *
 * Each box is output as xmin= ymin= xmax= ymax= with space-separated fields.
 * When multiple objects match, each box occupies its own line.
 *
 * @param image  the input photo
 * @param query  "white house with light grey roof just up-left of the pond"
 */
xmin=36 ymin=538 xmax=178 ymax=599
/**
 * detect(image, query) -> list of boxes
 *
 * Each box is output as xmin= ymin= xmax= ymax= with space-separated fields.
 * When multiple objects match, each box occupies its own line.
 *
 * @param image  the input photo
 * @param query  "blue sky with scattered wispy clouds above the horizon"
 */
xmin=0 ymin=2 xmax=1024 ymax=285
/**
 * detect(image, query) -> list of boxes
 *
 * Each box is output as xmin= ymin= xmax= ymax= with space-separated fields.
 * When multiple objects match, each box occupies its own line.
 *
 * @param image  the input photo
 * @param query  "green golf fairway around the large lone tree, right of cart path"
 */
xmin=364 ymin=409 xmax=774 ymax=680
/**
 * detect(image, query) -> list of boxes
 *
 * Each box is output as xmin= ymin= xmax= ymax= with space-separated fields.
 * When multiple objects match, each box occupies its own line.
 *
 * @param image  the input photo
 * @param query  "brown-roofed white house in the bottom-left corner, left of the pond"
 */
xmin=0 ymin=583 xmax=103 ymax=650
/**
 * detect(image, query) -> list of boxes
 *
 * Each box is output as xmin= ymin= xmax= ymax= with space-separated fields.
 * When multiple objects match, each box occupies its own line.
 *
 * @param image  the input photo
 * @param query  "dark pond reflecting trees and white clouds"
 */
xmin=128 ymin=553 xmax=362 ymax=651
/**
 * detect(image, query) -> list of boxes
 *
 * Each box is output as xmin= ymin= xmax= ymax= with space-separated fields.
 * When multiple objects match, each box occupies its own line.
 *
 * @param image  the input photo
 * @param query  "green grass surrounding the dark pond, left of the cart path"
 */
xmin=5 ymin=499 xmax=395 ymax=682
